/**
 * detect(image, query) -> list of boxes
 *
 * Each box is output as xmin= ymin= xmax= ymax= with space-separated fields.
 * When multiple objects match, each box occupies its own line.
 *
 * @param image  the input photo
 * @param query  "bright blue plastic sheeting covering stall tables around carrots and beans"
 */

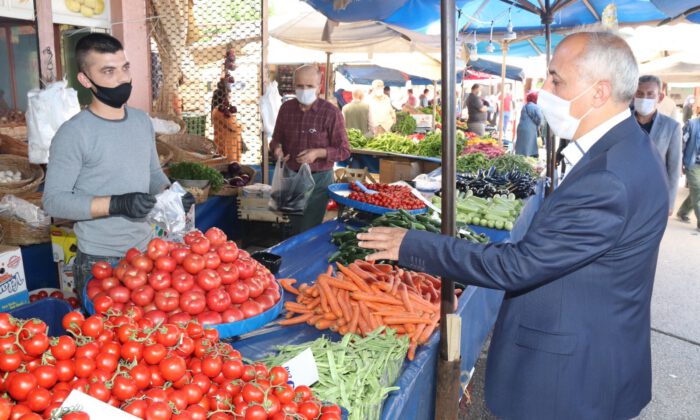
xmin=233 ymin=184 xmax=544 ymax=419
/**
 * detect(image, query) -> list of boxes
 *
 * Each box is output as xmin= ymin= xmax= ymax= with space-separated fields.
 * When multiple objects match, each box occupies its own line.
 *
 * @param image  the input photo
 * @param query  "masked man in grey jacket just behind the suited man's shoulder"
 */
xmin=634 ymin=76 xmax=681 ymax=216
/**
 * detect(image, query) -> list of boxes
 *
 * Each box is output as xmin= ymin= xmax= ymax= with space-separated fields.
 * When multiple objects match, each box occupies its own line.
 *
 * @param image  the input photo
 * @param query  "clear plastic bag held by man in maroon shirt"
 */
xmin=270 ymin=160 xmax=316 ymax=214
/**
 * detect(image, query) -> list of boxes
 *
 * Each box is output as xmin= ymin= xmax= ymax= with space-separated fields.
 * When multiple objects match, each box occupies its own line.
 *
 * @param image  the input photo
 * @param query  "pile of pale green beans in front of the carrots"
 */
xmin=263 ymin=327 xmax=408 ymax=420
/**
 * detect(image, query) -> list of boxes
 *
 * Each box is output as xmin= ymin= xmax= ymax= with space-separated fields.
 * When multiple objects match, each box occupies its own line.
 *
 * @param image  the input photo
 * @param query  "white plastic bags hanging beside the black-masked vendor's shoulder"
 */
xmin=26 ymin=80 xmax=80 ymax=164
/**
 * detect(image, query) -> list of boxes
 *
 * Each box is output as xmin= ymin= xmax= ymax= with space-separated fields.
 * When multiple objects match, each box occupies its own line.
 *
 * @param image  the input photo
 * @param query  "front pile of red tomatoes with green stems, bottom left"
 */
xmin=0 ymin=307 xmax=341 ymax=420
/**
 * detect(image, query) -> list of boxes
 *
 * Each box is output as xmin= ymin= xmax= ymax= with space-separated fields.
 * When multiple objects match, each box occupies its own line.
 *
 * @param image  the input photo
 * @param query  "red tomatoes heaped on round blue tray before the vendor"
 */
xmin=87 ymin=228 xmax=280 ymax=325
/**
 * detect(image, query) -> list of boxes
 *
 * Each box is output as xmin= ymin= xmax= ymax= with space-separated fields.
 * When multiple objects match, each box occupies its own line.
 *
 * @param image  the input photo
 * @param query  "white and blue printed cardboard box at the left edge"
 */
xmin=0 ymin=245 xmax=29 ymax=312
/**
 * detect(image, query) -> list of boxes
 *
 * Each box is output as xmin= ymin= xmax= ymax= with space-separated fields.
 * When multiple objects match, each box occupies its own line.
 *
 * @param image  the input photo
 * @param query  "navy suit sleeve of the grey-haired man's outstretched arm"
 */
xmin=399 ymin=171 xmax=628 ymax=292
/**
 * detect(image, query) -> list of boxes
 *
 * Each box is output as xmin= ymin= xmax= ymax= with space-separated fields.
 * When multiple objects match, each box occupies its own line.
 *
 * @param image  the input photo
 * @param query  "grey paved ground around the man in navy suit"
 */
xmin=461 ymin=188 xmax=700 ymax=420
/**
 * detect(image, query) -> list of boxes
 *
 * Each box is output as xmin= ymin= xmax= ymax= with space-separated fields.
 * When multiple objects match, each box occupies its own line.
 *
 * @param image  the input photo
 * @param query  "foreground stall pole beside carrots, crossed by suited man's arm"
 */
xmin=435 ymin=0 xmax=460 ymax=420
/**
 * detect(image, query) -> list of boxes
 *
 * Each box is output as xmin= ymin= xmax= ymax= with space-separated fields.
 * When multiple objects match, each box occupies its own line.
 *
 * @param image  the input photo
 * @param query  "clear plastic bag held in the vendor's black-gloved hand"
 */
xmin=146 ymin=182 xmax=187 ymax=242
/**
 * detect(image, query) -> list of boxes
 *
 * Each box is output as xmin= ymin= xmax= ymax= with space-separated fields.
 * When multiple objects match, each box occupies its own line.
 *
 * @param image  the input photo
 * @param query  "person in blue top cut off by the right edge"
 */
xmin=676 ymin=118 xmax=700 ymax=231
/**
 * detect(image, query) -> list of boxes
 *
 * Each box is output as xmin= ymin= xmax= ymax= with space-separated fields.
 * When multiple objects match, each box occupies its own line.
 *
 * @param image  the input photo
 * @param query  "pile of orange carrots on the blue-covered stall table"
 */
xmin=279 ymin=260 xmax=458 ymax=360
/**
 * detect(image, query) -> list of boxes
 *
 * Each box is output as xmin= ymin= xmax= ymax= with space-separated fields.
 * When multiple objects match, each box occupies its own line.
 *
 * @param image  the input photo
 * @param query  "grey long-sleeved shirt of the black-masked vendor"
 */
xmin=43 ymin=107 xmax=169 ymax=256
